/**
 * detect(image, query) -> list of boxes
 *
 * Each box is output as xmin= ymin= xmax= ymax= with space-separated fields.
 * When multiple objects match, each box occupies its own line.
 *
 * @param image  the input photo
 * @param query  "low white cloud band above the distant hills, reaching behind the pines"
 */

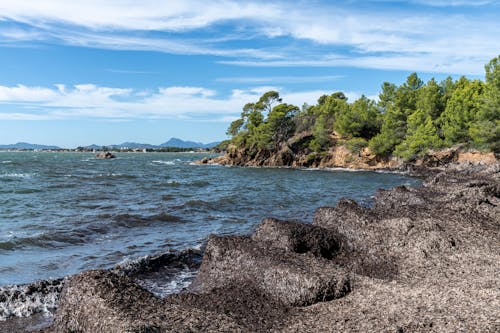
xmin=0 ymin=84 xmax=356 ymax=121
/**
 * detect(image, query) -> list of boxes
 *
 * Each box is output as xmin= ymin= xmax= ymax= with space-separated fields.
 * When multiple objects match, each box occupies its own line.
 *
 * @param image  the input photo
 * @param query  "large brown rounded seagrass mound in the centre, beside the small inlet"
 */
xmin=189 ymin=236 xmax=350 ymax=306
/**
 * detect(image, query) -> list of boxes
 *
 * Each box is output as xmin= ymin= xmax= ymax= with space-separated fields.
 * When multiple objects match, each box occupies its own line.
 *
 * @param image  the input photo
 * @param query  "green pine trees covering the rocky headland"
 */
xmin=221 ymin=56 xmax=500 ymax=160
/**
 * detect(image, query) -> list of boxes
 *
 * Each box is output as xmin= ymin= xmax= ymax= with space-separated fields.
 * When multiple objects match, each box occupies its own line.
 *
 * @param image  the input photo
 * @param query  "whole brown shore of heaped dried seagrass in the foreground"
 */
xmin=1 ymin=162 xmax=500 ymax=332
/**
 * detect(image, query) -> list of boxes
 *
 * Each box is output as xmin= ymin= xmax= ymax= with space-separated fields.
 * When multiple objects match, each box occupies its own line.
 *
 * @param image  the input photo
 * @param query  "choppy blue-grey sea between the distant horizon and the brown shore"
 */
xmin=0 ymin=152 xmax=419 ymax=285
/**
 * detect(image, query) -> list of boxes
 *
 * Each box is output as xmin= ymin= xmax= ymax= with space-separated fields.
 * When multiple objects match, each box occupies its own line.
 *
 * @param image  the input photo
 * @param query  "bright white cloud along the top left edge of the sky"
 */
xmin=0 ymin=0 xmax=279 ymax=31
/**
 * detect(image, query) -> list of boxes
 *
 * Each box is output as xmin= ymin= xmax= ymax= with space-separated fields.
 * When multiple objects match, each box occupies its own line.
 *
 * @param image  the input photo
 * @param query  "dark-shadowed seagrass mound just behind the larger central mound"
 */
xmin=252 ymin=218 xmax=344 ymax=259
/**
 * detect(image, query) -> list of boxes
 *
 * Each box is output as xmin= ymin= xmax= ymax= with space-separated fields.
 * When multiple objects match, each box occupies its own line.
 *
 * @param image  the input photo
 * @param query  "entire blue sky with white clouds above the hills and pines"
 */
xmin=0 ymin=0 xmax=500 ymax=148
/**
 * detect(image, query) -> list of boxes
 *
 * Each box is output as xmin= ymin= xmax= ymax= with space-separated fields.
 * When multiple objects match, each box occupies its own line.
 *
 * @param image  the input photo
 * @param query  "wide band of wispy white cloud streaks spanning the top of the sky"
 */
xmin=0 ymin=0 xmax=500 ymax=74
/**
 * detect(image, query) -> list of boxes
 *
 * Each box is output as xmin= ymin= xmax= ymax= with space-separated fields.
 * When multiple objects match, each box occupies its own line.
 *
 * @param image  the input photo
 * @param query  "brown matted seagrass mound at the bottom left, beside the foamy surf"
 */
xmin=51 ymin=270 xmax=240 ymax=333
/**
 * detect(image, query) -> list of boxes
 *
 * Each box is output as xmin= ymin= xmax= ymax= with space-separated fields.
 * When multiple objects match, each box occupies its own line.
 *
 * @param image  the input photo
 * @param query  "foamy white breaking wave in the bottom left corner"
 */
xmin=0 ymin=279 xmax=64 ymax=321
